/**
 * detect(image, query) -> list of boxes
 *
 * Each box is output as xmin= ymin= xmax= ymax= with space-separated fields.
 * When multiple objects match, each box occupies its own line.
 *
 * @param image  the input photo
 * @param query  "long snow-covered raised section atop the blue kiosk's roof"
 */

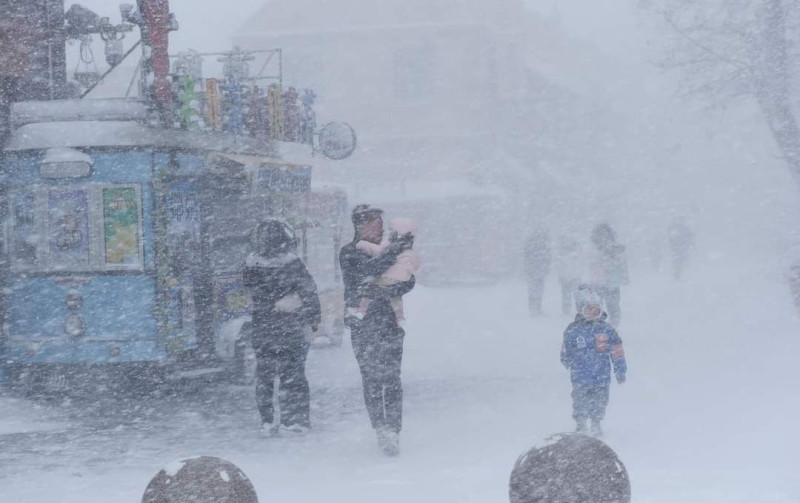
xmin=11 ymin=98 xmax=147 ymax=127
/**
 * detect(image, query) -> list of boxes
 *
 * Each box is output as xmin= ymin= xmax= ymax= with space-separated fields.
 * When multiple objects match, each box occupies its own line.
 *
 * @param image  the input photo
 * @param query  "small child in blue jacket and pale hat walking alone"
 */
xmin=561 ymin=287 xmax=628 ymax=436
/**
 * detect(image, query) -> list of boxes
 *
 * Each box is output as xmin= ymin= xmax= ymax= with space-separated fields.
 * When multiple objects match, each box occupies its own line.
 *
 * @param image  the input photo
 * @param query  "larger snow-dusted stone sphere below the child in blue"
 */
xmin=509 ymin=434 xmax=631 ymax=503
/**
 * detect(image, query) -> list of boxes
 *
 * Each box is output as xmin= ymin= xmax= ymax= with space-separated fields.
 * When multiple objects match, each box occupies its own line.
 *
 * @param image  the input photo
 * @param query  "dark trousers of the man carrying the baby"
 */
xmin=350 ymin=325 xmax=405 ymax=433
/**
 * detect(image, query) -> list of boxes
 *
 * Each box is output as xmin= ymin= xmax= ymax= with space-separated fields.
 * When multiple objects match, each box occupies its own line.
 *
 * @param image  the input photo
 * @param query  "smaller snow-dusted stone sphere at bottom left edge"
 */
xmin=142 ymin=456 xmax=258 ymax=503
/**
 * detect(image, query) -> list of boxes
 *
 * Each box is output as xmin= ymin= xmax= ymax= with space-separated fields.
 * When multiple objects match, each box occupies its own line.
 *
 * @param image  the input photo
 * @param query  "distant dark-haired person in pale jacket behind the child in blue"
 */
xmin=589 ymin=224 xmax=629 ymax=327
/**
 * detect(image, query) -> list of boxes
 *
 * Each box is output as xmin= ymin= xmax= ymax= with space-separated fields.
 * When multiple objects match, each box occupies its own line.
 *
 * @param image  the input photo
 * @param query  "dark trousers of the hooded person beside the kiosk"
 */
xmin=255 ymin=338 xmax=311 ymax=427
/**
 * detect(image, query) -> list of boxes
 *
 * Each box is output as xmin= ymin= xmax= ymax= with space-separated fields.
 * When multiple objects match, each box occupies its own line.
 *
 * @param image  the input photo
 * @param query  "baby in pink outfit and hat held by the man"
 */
xmin=352 ymin=218 xmax=420 ymax=325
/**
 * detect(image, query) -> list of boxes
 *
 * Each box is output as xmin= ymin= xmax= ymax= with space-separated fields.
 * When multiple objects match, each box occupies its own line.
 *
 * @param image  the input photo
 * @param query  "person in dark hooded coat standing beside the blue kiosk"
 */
xmin=243 ymin=219 xmax=321 ymax=435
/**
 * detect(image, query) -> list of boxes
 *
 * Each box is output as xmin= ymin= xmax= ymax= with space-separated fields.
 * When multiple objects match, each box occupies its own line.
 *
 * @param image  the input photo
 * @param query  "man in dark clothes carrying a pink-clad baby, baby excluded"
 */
xmin=339 ymin=205 xmax=415 ymax=456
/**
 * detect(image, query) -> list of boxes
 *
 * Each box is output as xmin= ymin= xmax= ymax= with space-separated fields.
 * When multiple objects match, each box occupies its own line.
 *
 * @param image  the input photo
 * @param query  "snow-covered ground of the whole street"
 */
xmin=0 ymin=260 xmax=800 ymax=503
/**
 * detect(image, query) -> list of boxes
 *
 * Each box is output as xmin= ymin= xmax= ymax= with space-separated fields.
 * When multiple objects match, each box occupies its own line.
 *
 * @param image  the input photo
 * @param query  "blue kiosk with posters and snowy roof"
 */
xmin=0 ymin=99 xmax=346 ymax=389
